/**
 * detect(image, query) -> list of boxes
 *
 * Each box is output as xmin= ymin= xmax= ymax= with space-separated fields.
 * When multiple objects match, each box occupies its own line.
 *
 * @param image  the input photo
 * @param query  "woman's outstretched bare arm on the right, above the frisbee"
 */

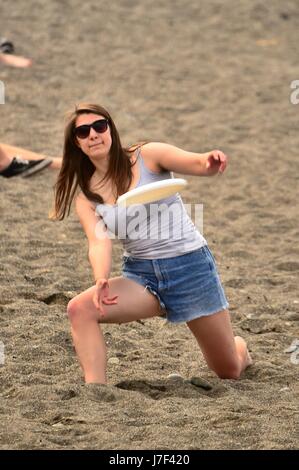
xmin=142 ymin=142 xmax=227 ymax=176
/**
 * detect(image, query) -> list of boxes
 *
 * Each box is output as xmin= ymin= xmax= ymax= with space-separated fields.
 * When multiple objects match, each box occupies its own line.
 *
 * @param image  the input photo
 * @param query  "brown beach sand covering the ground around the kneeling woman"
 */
xmin=0 ymin=0 xmax=299 ymax=450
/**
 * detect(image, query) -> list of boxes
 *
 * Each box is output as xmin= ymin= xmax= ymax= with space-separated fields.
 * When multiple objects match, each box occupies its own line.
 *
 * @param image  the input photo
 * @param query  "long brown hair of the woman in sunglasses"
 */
xmin=51 ymin=103 xmax=138 ymax=220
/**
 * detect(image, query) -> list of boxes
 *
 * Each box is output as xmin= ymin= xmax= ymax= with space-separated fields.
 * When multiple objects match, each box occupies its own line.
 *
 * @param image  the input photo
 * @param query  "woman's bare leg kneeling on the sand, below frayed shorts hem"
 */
xmin=187 ymin=310 xmax=252 ymax=379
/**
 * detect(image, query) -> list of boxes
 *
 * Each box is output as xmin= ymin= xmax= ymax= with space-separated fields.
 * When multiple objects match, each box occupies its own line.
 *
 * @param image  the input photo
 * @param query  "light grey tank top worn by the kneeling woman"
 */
xmin=96 ymin=148 xmax=207 ymax=259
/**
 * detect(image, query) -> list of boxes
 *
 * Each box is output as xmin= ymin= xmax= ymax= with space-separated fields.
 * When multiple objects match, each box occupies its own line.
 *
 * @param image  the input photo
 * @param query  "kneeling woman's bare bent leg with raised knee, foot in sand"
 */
xmin=67 ymin=277 xmax=161 ymax=384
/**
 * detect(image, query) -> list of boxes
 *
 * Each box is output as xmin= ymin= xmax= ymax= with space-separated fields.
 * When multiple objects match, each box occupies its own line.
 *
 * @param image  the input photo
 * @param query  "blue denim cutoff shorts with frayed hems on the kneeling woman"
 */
xmin=122 ymin=245 xmax=228 ymax=323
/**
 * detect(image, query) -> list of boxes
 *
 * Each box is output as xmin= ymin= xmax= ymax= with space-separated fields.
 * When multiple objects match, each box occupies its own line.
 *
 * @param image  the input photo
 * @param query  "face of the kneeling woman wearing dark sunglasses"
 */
xmin=75 ymin=113 xmax=112 ymax=162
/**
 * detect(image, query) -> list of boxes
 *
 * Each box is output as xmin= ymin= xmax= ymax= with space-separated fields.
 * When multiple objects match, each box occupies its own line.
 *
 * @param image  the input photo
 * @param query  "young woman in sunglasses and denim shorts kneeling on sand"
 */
xmin=55 ymin=104 xmax=251 ymax=384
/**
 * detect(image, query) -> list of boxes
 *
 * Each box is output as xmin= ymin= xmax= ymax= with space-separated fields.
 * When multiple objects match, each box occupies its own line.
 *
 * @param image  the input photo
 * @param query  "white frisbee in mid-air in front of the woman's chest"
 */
xmin=116 ymin=178 xmax=187 ymax=206
